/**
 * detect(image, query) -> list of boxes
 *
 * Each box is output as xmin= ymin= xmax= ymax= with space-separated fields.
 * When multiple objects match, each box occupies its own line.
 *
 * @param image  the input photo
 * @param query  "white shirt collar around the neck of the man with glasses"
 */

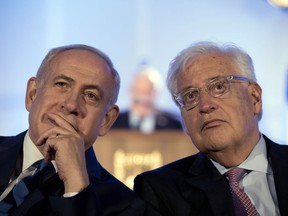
xmin=211 ymin=134 xmax=272 ymax=175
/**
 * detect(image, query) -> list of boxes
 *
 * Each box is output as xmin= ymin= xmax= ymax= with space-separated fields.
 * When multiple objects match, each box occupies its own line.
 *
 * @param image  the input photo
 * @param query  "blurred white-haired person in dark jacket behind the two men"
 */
xmin=112 ymin=66 xmax=182 ymax=134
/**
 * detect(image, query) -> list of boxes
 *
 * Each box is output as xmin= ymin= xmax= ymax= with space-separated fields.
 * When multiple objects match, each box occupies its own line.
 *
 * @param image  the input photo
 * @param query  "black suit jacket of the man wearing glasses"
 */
xmin=134 ymin=136 xmax=288 ymax=216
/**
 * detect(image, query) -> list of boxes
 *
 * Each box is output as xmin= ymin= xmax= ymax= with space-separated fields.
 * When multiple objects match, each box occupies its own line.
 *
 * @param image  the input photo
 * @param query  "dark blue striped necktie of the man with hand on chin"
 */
xmin=0 ymin=160 xmax=55 ymax=213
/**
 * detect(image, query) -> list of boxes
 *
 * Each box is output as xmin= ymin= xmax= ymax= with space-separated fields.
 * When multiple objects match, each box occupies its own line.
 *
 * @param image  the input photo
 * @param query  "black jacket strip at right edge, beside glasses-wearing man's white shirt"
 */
xmin=264 ymin=136 xmax=288 ymax=215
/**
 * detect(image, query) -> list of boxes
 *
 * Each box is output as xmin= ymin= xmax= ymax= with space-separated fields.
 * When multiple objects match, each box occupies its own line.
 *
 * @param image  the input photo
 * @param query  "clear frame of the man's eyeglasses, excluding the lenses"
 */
xmin=173 ymin=75 xmax=254 ymax=111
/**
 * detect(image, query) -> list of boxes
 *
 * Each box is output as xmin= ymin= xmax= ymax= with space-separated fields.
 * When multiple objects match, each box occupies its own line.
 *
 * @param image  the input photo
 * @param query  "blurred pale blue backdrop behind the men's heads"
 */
xmin=0 ymin=0 xmax=288 ymax=143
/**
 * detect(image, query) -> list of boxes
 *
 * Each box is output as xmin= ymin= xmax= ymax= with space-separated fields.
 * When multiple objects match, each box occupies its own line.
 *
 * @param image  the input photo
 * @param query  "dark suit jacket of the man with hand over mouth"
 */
xmin=0 ymin=132 xmax=144 ymax=216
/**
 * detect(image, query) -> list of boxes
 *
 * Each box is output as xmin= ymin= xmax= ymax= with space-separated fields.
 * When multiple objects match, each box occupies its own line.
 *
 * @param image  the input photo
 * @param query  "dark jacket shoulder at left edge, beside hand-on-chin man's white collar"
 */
xmin=0 ymin=131 xmax=26 ymax=194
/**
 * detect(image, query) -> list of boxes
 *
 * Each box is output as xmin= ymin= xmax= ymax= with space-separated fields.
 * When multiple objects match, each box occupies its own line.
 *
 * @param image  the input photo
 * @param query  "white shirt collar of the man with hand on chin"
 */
xmin=22 ymin=131 xmax=44 ymax=170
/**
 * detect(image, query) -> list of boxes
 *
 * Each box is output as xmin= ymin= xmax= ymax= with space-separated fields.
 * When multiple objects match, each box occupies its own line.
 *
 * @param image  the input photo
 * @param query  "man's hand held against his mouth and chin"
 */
xmin=36 ymin=114 xmax=89 ymax=193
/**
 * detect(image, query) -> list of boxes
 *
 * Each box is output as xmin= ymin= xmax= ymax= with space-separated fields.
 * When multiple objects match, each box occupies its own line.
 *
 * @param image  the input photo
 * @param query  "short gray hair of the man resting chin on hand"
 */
xmin=36 ymin=44 xmax=120 ymax=104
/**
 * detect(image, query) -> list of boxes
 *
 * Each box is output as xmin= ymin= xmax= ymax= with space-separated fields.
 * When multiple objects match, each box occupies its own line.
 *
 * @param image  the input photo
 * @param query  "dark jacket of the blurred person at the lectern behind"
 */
xmin=112 ymin=111 xmax=182 ymax=130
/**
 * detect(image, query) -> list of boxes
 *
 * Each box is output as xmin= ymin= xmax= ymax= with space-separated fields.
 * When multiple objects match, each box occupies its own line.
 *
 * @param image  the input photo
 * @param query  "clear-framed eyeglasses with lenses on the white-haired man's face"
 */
xmin=174 ymin=76 xmax=252 ymax=111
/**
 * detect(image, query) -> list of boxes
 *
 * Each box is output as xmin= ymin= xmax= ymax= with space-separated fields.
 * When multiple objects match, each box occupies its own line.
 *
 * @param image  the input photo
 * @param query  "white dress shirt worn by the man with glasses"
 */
xmin=211 ymin=135 xmax=280 ymax=216
